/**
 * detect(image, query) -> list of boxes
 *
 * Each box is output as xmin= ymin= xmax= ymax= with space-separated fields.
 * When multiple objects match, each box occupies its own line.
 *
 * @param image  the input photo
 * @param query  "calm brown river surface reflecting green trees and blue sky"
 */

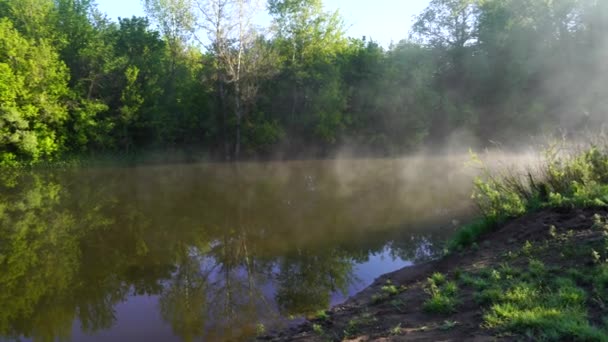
xmin=0 ymin=160 xmax=476 ymax=341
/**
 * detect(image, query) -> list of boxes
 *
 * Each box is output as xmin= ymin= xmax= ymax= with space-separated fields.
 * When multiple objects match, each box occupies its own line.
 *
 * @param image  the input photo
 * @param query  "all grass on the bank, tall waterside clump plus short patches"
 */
xmin=442 ymin=146 xmax=608 ymax=341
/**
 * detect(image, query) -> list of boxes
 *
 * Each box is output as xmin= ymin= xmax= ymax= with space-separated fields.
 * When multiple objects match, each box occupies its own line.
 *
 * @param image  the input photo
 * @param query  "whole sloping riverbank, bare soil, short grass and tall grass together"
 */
xmin=266 ymin=144 xmax=608 ymax=341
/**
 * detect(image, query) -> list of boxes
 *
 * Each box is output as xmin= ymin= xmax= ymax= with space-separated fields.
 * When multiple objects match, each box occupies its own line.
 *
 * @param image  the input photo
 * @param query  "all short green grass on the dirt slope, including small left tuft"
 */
xmin=430 ymin=222 xmax=608 ymax=341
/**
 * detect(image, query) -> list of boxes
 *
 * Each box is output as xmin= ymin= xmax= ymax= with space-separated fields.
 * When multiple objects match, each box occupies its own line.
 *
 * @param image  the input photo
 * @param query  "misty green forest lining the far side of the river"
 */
xmin=0 ymin=0 xmax=608 ymax=165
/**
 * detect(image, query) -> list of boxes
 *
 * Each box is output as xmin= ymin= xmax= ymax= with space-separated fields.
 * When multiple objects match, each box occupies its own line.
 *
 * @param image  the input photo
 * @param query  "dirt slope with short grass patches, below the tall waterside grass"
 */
xmin=262 ymin=208 xmax=608 ymax=341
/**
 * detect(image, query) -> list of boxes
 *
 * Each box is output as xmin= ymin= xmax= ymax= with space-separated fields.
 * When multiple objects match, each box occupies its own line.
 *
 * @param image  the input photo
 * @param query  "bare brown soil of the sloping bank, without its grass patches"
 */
xmin=258 ymin=208 xmax=608 ymax=341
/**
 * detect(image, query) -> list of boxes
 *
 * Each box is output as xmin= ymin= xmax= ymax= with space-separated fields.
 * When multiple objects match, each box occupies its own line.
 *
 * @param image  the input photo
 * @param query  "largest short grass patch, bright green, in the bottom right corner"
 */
xmin=458 ymin=243 xmax=608 ymax=341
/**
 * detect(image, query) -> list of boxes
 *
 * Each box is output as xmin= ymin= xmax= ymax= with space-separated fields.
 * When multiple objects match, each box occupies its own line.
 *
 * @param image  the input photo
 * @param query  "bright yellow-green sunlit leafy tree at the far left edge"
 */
xmin=0 ymin=19 xmax=68 ymax=164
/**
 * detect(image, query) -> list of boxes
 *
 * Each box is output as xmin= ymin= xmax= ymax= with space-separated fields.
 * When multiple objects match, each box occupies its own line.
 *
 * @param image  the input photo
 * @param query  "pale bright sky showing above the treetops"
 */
xmin=97 ymin=0 xmax=429 ymax=47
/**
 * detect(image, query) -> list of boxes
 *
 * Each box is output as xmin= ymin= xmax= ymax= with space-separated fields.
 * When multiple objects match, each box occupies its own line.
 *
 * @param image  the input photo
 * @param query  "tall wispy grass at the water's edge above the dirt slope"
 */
xmin=448 ymin=143 xmax=608 ymax=251
